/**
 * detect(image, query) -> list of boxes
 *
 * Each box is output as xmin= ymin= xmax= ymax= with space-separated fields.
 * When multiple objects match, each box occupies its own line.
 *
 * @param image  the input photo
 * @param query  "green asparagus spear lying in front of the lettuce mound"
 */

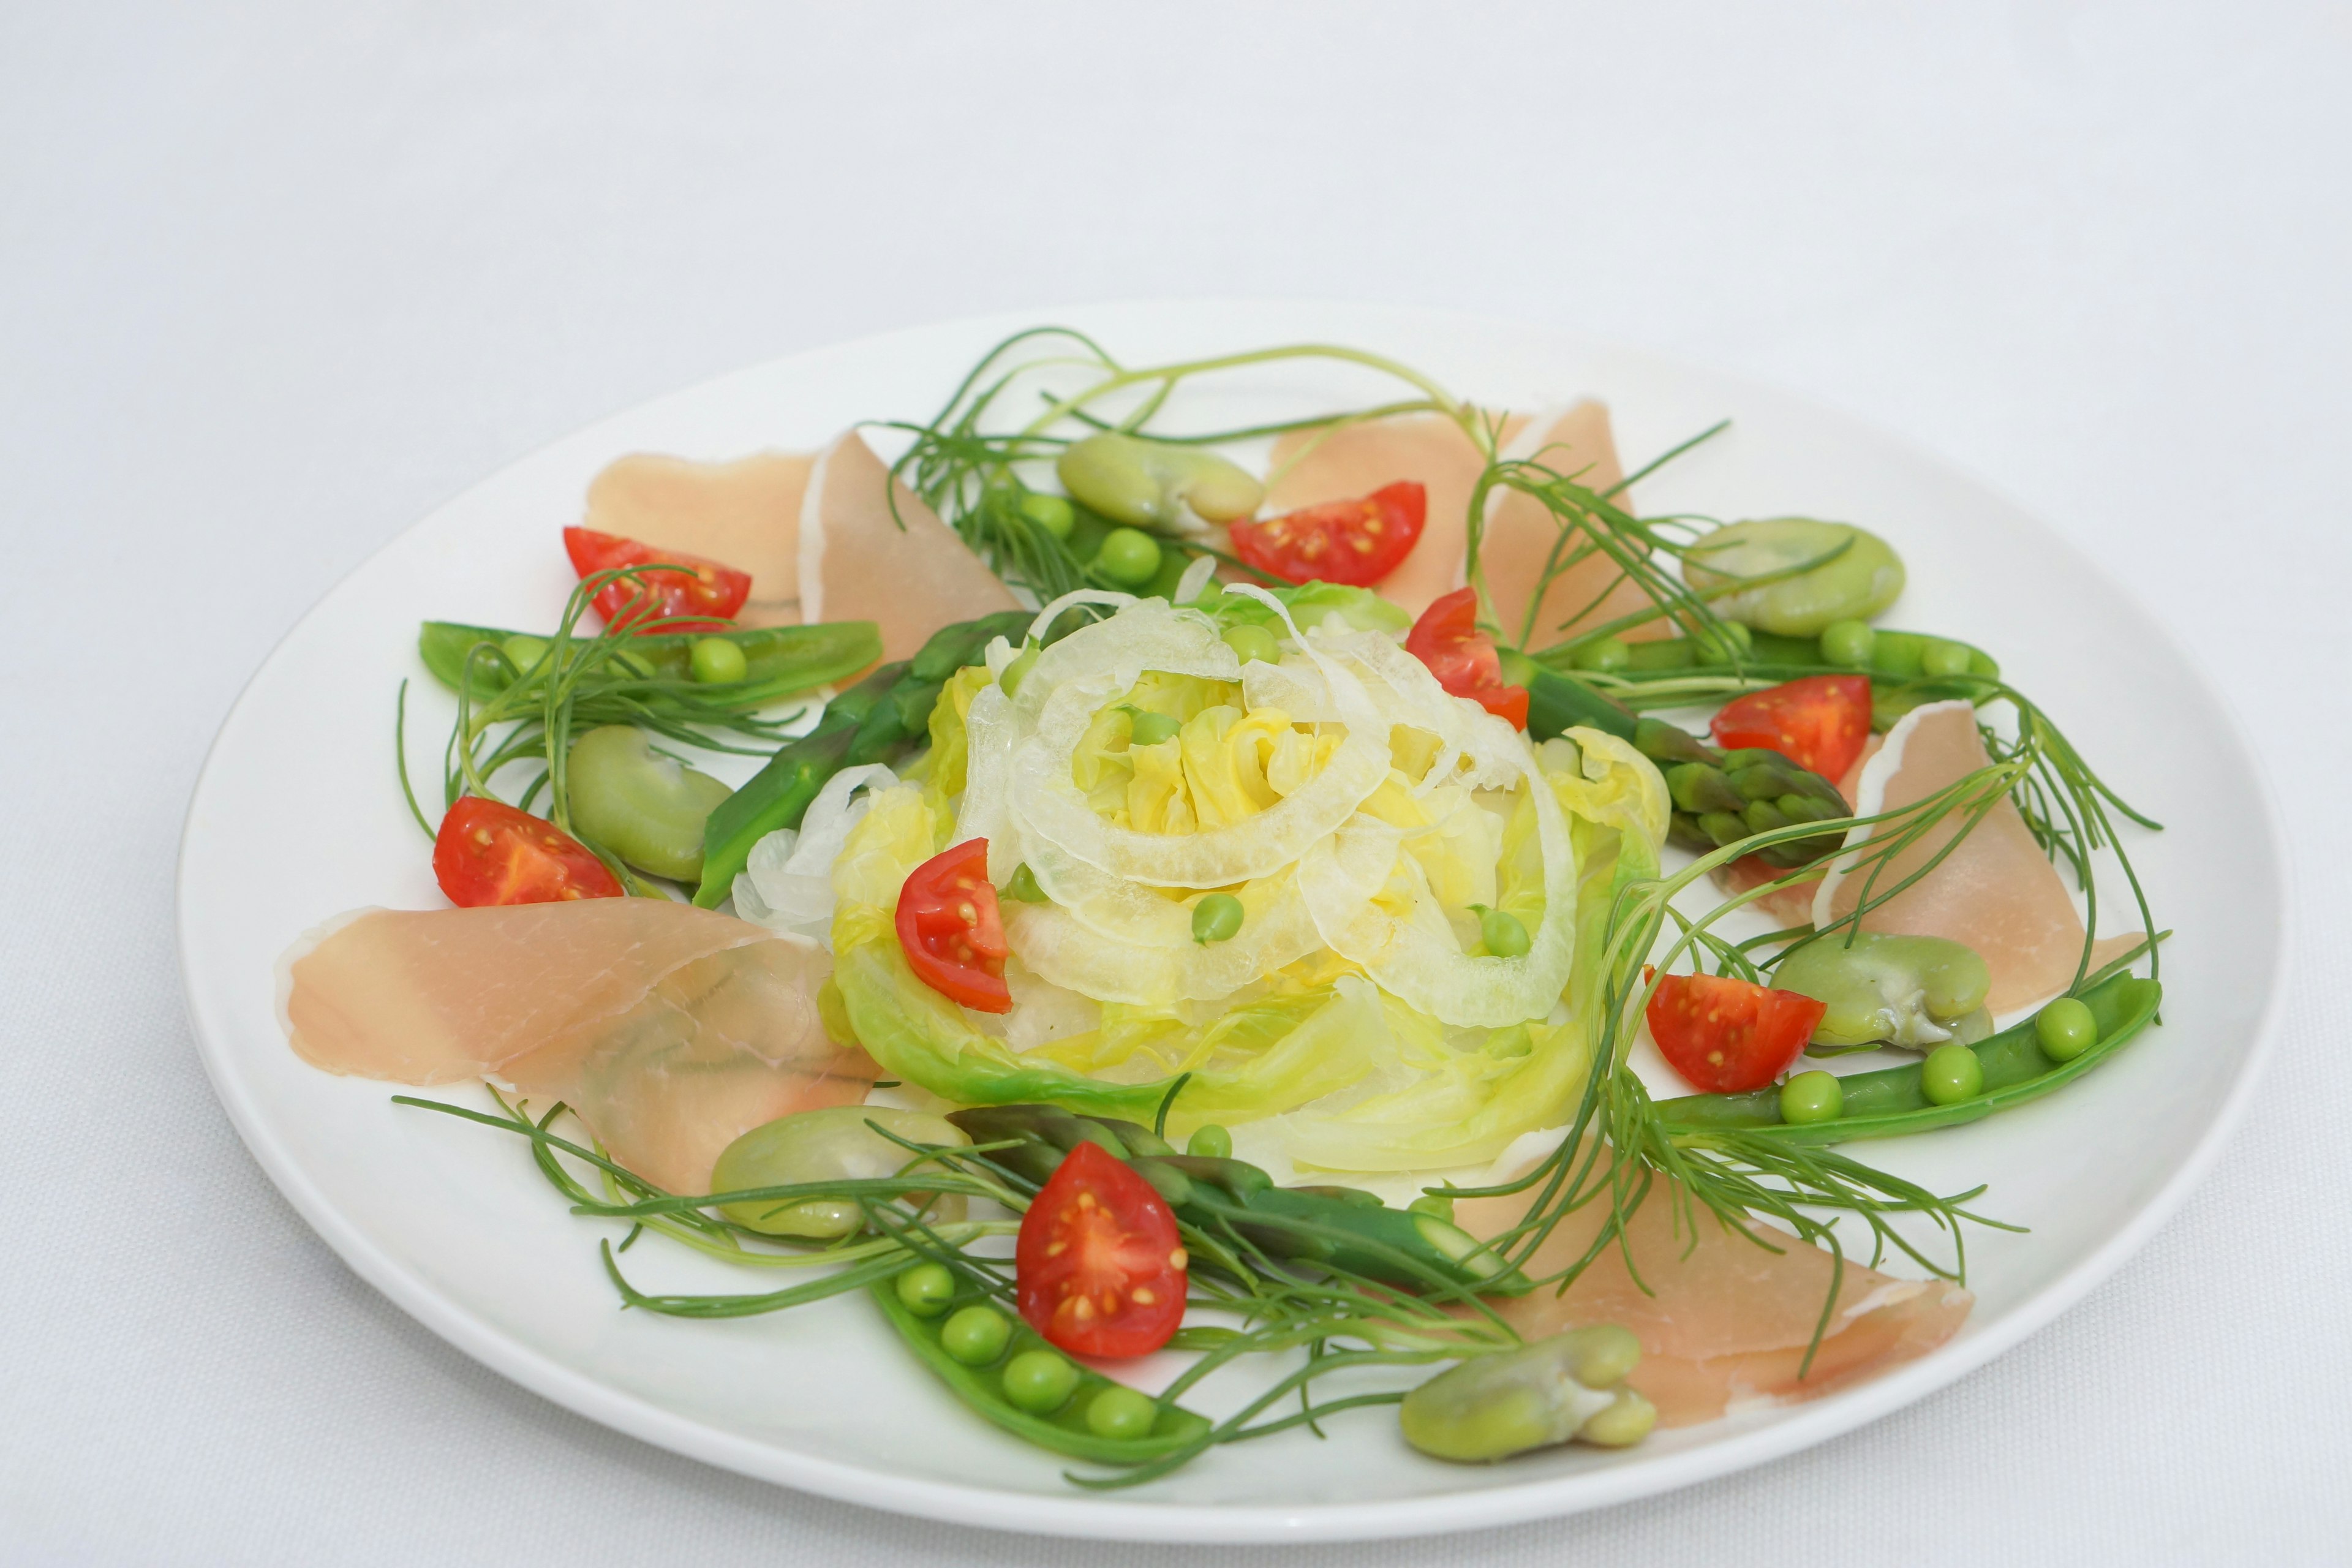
xmin=948 ymin=1105 xmax=1526 ymax=1293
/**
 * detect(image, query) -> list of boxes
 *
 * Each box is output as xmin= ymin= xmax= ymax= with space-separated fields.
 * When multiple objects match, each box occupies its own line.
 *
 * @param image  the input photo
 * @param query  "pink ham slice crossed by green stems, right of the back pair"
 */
xmin=1479 ymin=399 xmax=1675 ymax=649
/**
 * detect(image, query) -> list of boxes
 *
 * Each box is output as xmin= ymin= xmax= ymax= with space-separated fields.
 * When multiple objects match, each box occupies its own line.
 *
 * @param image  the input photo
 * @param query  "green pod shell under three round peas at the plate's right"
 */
xmin=1658 ymin=973 xmax=2164 ymax=1142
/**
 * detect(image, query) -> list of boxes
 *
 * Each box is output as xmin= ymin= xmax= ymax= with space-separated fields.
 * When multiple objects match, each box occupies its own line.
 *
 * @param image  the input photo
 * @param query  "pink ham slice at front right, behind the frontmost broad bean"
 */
xmin=1453 ymin=1161 xmax=1976 ymax=1427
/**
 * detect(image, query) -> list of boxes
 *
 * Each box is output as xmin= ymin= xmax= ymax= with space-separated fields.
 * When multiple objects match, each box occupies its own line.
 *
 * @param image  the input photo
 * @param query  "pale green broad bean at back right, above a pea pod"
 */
xmin=1682 ymin=517 xmax=1903 ymax=637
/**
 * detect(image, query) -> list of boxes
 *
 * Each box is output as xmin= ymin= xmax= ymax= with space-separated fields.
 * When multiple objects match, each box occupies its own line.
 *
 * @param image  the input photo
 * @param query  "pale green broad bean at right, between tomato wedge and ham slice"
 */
xmin=1771 ymin=931 xmax=1992 ymax=1049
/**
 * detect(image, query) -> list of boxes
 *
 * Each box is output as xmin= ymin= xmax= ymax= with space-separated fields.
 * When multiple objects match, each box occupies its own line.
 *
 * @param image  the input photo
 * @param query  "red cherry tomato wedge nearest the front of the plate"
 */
xmin=1014 ymin=1142 xmax=1185 ymax=1357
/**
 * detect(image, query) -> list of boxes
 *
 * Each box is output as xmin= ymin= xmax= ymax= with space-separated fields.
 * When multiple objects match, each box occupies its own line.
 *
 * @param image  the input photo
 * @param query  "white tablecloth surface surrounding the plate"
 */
xmin=0 ymin=5 xmax=2352 ymax=1568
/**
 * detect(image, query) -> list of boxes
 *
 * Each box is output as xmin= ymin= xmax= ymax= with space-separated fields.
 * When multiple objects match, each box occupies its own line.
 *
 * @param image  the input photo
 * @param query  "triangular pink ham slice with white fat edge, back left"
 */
xmin=800 ymin=430 xmax=1021 ymax=658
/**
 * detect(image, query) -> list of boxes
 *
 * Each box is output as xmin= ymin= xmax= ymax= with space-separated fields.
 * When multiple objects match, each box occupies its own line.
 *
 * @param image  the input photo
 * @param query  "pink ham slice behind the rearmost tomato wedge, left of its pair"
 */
xmin=1263 ymin=414 xmax=1526 ymax=616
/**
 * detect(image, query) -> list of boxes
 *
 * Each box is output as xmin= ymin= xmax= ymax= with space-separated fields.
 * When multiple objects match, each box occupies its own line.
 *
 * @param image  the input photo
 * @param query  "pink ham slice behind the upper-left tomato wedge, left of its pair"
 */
xmin=581 ymin=451 xmax=816 ymax=625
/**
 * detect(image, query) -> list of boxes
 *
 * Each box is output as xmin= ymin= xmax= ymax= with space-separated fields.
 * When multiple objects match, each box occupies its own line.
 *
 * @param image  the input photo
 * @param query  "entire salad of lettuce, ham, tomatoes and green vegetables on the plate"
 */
xmin=266 ymin=331 xmax=2162 ymax=1486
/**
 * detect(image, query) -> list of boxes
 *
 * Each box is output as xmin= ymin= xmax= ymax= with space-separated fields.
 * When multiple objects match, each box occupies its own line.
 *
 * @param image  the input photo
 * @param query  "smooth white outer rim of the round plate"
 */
xmin=172 ymin=296 xmax=2298 ymax=1545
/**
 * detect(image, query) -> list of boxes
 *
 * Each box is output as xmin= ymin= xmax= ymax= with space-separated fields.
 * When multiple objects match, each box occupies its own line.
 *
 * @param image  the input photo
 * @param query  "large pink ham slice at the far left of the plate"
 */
xmin=282 ymin=898 xmax=877 ymax=1192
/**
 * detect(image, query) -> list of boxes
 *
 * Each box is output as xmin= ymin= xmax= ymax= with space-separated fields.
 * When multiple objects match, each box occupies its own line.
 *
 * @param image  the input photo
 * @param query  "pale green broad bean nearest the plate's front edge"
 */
xmin=1397 ymin=1324 xmax=1658 ymax=1464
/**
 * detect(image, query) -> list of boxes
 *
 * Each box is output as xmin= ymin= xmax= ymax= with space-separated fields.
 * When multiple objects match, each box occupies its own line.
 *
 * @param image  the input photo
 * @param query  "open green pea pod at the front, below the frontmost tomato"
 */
xmin=873 ymin=1286 xmax=1209 ymax=1464
